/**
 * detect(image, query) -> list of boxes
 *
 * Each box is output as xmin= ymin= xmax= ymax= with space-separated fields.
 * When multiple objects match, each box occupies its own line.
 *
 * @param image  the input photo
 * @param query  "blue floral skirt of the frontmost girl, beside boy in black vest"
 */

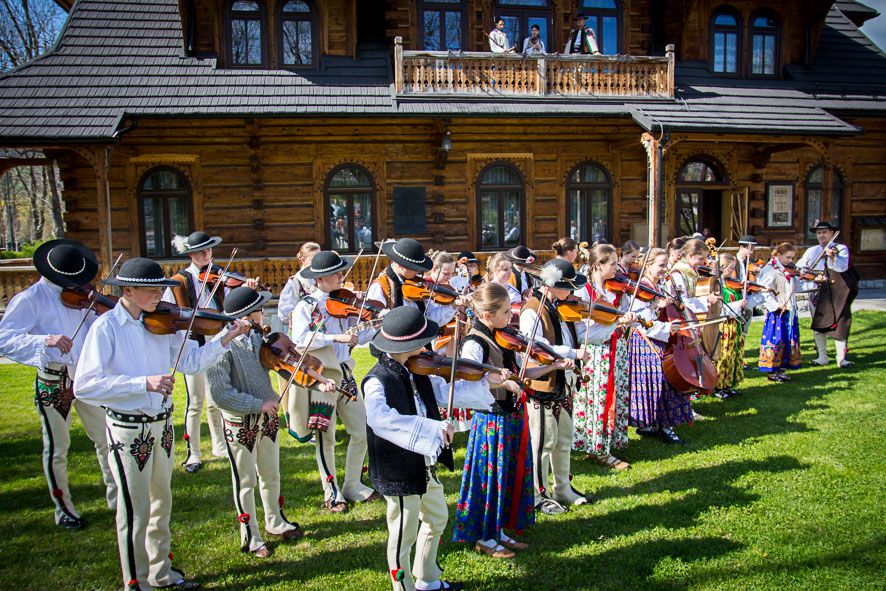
xmin=452 ymin=408 xmax=535 ymax=542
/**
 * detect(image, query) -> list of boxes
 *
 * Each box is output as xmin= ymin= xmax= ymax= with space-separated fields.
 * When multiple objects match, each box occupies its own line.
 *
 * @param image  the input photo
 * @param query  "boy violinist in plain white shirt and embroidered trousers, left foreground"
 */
xmin=74 ymin=258 xmax=250 ymax=591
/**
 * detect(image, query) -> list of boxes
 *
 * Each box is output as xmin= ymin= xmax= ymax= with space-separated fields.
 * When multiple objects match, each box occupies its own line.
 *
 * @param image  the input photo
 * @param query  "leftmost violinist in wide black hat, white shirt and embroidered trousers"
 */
xmin=0 ymin=240 xmax=117 ymax=529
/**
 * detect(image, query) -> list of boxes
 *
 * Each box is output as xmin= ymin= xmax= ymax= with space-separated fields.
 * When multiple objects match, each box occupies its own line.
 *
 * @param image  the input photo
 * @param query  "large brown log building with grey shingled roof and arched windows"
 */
xmin=0 ymin=0 xmax=886 ymax=295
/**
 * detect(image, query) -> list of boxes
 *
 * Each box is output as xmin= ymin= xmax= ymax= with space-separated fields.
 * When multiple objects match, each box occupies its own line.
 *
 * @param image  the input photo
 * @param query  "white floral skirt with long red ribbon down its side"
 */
xmin=572 ymin=338 xmax=631 ymax=455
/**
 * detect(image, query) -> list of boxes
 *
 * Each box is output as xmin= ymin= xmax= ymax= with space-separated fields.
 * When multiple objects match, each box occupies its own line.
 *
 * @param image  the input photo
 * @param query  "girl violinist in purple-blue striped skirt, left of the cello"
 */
xmin=628 ymin=247 xmax=701 ymax=445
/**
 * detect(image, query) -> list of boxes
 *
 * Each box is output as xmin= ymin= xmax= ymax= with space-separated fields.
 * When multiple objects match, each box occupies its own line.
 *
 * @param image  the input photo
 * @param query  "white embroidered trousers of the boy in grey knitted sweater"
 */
xmin=222 ymin=411 xmax=298 ymax=552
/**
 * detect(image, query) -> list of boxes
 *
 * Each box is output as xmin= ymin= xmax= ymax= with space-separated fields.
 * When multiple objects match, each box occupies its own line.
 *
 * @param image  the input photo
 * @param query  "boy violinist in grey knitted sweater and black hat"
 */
xmin=206 ymin=286 xmax=301 ymax=558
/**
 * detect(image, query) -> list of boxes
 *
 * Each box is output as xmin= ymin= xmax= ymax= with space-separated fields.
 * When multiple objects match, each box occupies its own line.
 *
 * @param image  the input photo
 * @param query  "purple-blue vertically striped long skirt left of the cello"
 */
xmin=628 ymin=331 xmax=692 ymax=429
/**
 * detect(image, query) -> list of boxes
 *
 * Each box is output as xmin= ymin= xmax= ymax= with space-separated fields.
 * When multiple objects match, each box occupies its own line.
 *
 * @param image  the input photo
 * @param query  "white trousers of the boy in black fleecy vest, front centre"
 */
xmin=385 ymin=472 xmax=449 ymax=591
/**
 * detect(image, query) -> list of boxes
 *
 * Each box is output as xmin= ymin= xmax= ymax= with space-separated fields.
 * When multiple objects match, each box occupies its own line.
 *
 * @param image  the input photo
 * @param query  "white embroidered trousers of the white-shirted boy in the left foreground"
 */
xmin=105 ymin=414 xmax=181 ymax=591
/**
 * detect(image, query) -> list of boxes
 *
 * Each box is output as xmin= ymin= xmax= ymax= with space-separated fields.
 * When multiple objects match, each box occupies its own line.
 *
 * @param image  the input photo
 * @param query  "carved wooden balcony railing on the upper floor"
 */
xmin=394 ymin=37 xmax=674 ymax=99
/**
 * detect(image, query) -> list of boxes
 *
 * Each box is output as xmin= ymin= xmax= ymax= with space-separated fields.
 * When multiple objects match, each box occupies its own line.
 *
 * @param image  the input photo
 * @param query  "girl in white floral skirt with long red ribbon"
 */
xmin=572 ymin=244 xmax=633 ymax=470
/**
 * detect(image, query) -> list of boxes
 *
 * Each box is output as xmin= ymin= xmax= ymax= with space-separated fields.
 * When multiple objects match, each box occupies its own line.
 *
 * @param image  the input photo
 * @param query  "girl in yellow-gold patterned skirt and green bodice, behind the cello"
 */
xmin=714 ymin=252 xmax=746 ymax=399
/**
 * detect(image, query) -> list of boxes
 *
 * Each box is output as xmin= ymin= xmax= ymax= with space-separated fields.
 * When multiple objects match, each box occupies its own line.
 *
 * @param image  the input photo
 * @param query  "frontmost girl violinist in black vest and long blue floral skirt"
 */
xmin=452 ymin=283 xmax=573 ymax=558
